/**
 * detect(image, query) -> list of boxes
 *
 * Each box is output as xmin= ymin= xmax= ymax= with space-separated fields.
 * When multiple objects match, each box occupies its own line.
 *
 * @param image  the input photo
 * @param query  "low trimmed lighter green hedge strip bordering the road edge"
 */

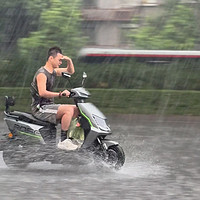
xmin=0 ymin=87 xmax=200 ymax=116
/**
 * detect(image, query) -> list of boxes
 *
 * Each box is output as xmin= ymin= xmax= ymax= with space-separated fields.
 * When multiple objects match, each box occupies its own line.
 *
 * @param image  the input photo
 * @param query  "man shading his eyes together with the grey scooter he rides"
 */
xmin=3 ymin=47 xmax=125 ymax=169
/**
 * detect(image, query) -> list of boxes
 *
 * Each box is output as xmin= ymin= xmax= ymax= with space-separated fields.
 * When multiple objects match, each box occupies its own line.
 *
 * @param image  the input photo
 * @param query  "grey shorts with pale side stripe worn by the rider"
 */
xmin=32 ymin=104 xmax=60 ymax=124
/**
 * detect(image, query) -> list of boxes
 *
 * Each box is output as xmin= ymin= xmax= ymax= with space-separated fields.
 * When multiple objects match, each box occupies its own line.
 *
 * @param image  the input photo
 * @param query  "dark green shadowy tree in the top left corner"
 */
xmin=0 ymin=0 xmax=38 ymax=55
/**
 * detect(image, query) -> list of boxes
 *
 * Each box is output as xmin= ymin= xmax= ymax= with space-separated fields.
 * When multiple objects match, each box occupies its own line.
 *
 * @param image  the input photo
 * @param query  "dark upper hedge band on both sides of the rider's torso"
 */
xmin=0 ymin=59 xmax=200 ymax=90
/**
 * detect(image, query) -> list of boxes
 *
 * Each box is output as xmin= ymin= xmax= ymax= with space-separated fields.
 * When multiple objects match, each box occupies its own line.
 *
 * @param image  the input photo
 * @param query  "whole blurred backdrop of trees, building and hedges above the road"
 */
xmin=0 ymin=0 xmax=200 ymax=115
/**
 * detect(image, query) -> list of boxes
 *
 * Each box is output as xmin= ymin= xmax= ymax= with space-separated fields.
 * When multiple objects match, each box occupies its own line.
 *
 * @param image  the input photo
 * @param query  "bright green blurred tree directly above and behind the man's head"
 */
xmin=18 ymin=0 xmax=84 ymax=60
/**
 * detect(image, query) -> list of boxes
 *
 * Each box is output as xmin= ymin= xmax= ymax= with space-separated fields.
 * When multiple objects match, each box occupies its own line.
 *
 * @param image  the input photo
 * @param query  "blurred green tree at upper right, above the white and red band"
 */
xmin=130 ymin=1 xmax=197 ymax=50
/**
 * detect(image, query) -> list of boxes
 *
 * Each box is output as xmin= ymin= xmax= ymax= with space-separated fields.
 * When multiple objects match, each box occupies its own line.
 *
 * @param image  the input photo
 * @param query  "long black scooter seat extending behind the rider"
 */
xmin=10 ymin=111 xmax=55 ymax=126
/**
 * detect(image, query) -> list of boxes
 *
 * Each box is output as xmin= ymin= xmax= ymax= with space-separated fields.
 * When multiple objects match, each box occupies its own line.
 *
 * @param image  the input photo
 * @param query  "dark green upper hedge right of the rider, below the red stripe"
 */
xmin=76 ymin=59 xmax=200 ymax=90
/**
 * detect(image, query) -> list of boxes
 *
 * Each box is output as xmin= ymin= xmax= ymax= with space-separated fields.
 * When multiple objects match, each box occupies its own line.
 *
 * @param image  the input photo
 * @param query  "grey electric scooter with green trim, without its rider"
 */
xmin=3 ymin=72 xmax=125 ymax=169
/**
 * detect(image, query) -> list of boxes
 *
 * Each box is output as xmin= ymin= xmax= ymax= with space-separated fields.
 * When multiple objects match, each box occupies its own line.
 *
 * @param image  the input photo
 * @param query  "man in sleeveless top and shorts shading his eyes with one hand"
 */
xmin=31 ymin=47 xmax=79 ymax=150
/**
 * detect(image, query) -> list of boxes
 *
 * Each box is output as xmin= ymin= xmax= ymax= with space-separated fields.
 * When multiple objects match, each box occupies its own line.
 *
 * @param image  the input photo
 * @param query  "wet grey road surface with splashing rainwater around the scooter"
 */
xmin=0 ymin=115 xmax=200 ymax=200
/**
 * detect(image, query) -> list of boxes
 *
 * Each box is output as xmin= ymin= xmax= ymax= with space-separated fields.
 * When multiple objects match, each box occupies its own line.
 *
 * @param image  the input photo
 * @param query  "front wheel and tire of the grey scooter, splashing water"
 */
xmin=106 ymin=145 xmax=125 ymax=170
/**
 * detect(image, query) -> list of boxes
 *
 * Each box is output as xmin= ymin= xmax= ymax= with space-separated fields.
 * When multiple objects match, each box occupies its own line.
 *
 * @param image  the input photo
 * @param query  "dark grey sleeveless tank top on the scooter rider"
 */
xmin=30 ymin=67 xmax=56 ymax=108
